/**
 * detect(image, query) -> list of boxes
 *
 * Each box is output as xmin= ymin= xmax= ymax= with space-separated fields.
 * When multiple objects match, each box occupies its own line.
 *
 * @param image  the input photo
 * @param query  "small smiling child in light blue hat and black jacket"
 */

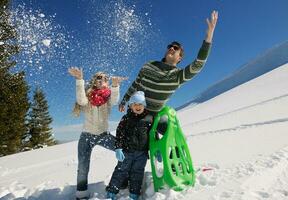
xmin=106 ymin=91 xmax=153 ymax=200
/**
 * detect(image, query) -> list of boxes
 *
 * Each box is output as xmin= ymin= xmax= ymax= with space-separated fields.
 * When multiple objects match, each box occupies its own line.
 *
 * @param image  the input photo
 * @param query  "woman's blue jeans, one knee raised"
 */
xmin=77 ymin=132 xmax=115 ymax=191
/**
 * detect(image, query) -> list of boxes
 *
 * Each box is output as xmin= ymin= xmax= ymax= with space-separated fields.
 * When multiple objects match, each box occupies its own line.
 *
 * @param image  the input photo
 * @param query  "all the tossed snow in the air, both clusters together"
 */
xmin=8 ymin=0 xmax=160 ymax=95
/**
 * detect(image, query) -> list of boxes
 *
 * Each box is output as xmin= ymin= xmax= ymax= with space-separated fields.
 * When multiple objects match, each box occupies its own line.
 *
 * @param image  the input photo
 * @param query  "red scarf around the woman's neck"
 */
xmin=89 ymin=88 xmax=111 ymax=107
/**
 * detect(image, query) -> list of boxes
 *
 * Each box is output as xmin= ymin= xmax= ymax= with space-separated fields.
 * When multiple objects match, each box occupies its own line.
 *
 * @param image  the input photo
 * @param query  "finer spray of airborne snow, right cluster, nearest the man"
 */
xmin=86 ymin=1 xmax=158 ymax=76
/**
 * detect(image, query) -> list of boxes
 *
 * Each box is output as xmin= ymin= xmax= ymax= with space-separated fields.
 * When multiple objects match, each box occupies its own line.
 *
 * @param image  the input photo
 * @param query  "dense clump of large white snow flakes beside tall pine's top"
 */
xmin=10 ymin=4 xmax=69 ymax=67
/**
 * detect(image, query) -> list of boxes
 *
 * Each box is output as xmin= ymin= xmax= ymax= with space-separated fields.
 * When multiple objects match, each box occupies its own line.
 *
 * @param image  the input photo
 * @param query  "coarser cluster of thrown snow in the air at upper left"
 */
xmin=10 ymin=4 xmax=69 ymax=85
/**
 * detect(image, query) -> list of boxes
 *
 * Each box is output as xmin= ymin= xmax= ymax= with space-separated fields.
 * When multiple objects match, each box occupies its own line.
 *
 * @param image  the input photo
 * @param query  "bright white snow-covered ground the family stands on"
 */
xmin=0 ymin=61 xmax=288 ymax=200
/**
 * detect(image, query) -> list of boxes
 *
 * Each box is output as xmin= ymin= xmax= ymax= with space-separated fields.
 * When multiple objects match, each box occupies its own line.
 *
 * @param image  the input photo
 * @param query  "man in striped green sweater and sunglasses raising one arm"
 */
xmin=119 ymin=11 xmax=218 ymax=115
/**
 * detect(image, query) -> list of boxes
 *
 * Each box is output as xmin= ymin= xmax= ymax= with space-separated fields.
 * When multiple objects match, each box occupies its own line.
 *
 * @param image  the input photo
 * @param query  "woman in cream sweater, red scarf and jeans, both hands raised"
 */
xmin=68 ymin=67 xmax=124 ymax=199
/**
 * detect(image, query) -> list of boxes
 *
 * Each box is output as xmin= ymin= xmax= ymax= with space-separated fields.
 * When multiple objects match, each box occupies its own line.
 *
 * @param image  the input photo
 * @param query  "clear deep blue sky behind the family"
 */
xmin=12 ymin=0 xmax=288 ymax=141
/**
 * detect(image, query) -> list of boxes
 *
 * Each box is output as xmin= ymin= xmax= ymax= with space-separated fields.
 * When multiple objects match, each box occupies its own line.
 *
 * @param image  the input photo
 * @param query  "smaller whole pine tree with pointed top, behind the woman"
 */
xmin=26 ymin=88 xmax=56 ymax=149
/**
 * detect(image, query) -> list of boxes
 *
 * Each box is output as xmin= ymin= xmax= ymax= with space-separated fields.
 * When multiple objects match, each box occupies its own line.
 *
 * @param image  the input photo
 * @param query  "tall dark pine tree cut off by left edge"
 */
xmin=0 ymin=0 xmax=29 ymax=156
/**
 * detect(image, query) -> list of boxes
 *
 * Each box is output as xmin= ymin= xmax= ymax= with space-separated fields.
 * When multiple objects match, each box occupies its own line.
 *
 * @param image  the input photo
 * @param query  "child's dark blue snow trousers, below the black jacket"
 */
xmin=106 ymin=151 xmax=148 ymax=195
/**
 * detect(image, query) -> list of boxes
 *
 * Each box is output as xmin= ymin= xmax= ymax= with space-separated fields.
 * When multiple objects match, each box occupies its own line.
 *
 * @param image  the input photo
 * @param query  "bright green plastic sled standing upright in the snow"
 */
xmin=149 ymin=106 xmax=195 ymax=192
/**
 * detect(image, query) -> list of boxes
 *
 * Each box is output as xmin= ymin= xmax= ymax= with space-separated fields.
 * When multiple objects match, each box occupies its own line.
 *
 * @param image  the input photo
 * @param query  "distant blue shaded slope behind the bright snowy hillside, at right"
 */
xmin=177 ymin=41 xmax=288 ymax=110
